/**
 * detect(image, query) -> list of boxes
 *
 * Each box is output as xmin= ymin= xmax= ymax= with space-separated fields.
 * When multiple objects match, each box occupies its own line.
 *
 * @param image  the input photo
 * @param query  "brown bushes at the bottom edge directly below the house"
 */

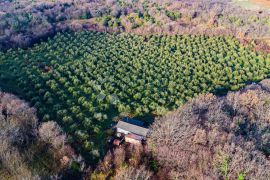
xmin=90 ymin=144 xmax=153 ymax=180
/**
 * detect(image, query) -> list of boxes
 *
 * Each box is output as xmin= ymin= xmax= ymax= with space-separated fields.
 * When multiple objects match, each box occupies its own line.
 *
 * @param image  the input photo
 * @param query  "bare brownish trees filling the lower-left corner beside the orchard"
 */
xmin=0 ymin=92 xmax=74 ymax=179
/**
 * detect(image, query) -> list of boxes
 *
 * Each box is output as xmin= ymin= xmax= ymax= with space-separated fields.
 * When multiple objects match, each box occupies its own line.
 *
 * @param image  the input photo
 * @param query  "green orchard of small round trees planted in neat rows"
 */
xmin=0 ymin=32 xmax=270 ymax=160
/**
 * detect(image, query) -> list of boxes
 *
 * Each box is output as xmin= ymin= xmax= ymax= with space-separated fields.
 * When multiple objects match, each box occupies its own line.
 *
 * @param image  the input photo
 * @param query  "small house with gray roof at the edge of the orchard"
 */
xmin=116 ymin=118 xmax=149 ymax=144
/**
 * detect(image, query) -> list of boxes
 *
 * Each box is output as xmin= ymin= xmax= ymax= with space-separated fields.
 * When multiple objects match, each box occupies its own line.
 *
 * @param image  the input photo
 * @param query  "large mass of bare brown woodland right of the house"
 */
xmin=148 ymin=80 xmax=270 ymax=179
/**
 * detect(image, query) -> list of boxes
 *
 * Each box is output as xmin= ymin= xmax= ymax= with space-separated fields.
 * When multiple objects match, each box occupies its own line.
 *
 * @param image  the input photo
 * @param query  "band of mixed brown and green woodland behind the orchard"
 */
xmin=0 ymin=0 xmax=270 ymax=50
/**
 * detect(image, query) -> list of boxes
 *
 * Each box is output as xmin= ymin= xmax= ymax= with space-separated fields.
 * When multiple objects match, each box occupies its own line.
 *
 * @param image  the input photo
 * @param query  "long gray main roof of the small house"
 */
xmin=116 ymin=121 xmax=149 ymax=136
